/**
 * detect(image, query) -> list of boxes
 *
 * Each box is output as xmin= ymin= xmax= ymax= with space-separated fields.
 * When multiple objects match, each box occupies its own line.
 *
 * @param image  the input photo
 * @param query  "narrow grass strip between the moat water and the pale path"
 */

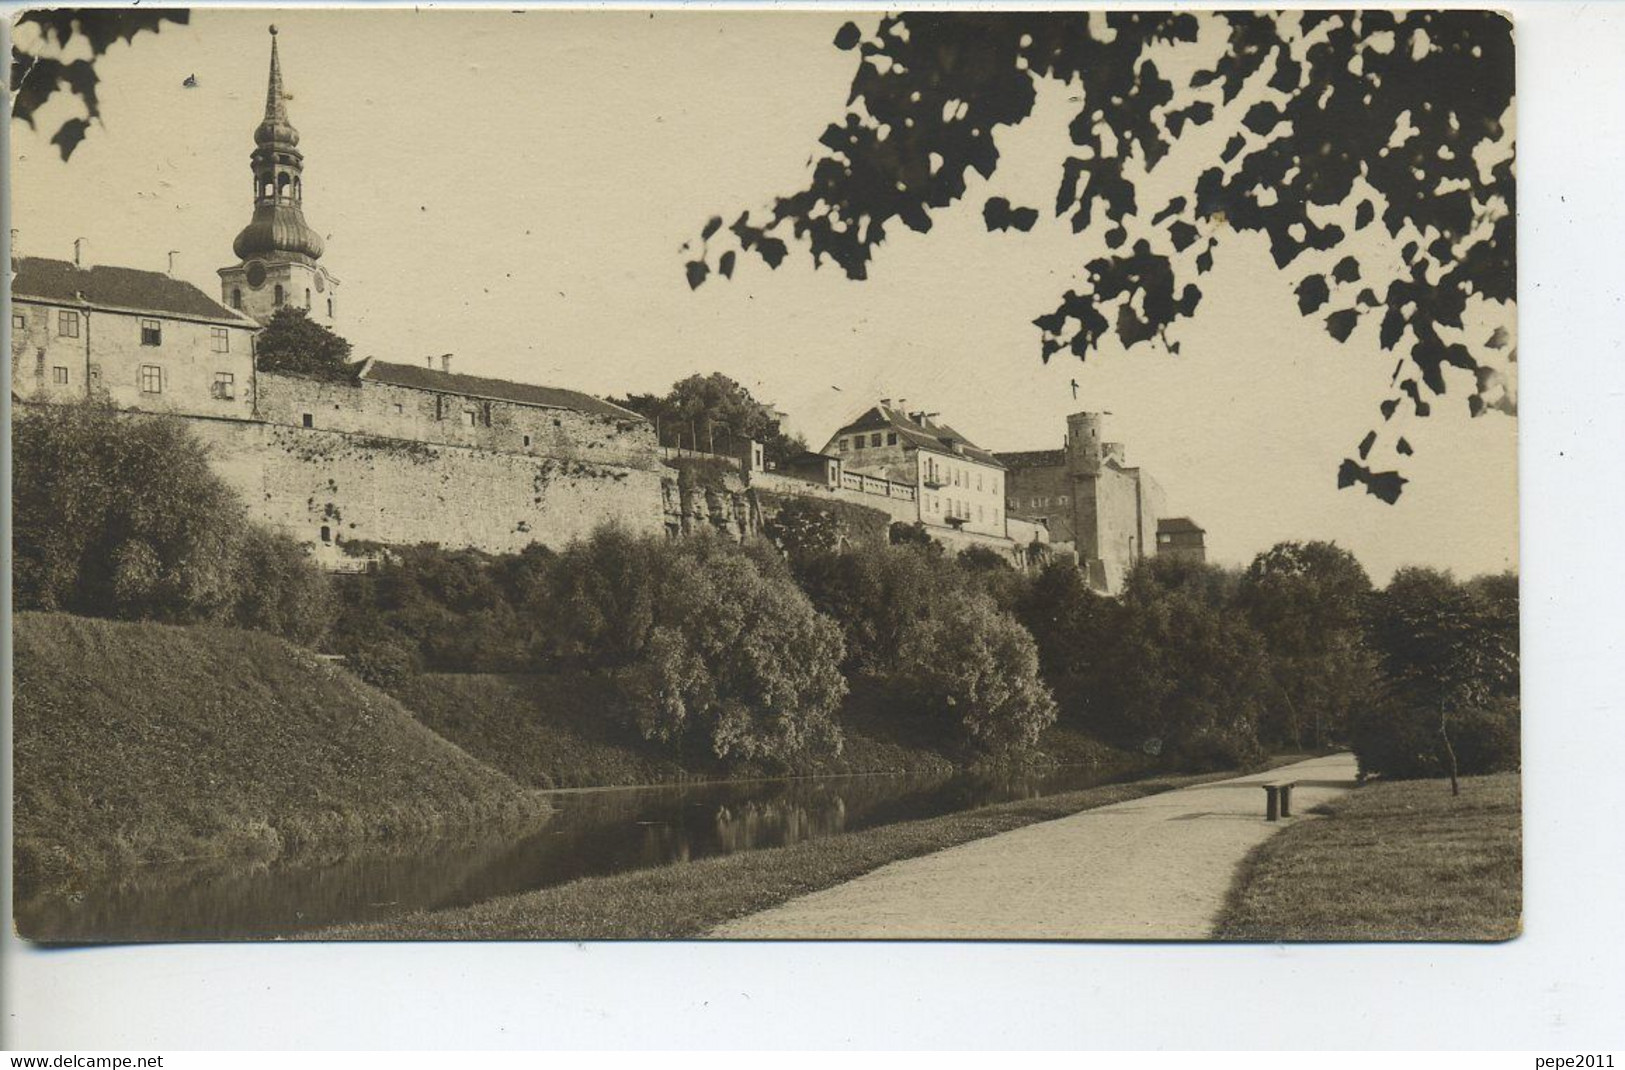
xmin=316 ymin=772 xmax=1254 ymax=940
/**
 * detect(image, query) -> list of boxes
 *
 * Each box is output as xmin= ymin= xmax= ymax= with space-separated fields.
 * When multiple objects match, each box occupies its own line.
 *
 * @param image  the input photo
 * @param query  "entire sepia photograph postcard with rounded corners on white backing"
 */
xmin=7 ymin=7 xmax=1514 ymax=953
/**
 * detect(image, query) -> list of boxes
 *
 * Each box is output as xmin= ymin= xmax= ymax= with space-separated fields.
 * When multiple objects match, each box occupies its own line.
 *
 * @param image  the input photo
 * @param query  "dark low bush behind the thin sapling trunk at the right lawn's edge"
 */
xmin=1352 ymin=698 xmax=1521 ymax=781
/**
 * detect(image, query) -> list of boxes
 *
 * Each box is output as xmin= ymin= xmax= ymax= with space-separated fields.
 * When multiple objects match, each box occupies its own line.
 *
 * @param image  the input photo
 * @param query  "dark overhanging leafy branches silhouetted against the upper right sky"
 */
xmin=686 ymin=11 xmax=1516 ymax=502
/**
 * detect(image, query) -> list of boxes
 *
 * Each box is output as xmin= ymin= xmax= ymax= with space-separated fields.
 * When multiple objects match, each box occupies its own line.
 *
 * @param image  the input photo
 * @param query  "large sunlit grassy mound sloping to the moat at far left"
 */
xmin=13 ymin=613 xmax=546 ymax=880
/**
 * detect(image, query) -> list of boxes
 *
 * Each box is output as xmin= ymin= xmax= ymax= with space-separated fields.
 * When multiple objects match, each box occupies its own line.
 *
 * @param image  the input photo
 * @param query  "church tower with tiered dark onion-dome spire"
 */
xmin=219 ymin=26 xmax=338 ymax=327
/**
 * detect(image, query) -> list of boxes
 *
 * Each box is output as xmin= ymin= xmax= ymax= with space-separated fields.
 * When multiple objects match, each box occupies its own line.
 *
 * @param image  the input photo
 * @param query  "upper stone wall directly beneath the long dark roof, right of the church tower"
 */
xmin=257 ymin=372 xmax=660 ymax=470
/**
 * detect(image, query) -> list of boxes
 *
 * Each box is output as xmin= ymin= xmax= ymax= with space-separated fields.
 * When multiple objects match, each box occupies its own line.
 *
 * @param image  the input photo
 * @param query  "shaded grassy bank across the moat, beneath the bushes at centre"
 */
xmin=393 ymin=673 xmax=1121 ymax=787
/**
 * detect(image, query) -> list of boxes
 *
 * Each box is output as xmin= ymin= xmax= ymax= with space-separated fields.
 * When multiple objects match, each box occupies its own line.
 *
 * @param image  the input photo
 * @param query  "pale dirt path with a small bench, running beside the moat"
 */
xmin=710 ymin=744 xmax=1355 ymax=940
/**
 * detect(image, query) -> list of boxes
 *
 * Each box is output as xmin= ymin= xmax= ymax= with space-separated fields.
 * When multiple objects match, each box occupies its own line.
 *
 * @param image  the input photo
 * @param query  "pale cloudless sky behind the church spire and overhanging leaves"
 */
xmin=11 ymin=10 xmax=1516 ymax=582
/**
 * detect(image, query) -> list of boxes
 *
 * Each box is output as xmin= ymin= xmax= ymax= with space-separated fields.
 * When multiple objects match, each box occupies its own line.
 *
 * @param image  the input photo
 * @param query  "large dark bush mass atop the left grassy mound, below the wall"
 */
xmin=11 ymin=395 xmax=332 ymax=642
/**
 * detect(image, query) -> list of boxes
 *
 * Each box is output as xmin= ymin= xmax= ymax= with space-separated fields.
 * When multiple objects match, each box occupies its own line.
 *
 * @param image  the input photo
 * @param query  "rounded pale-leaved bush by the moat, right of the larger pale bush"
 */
xmin=899 ymin=594 xmax=1055 ymax=755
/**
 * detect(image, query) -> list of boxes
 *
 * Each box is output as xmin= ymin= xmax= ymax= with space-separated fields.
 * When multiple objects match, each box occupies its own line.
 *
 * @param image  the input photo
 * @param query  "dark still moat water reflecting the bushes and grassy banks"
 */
xmin=15 ymin=769 xmax=1123 ymax=943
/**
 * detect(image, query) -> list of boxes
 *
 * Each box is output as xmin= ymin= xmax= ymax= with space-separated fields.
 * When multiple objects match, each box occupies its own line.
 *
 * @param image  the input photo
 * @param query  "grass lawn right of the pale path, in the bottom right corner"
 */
xmin=1214 ymin=772 xmax=1523 ymax=940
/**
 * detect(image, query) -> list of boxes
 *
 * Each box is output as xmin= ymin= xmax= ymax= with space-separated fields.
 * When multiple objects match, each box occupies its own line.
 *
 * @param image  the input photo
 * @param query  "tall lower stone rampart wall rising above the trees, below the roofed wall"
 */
xmin=185 ymin=418 xmax=661 ymax=566
